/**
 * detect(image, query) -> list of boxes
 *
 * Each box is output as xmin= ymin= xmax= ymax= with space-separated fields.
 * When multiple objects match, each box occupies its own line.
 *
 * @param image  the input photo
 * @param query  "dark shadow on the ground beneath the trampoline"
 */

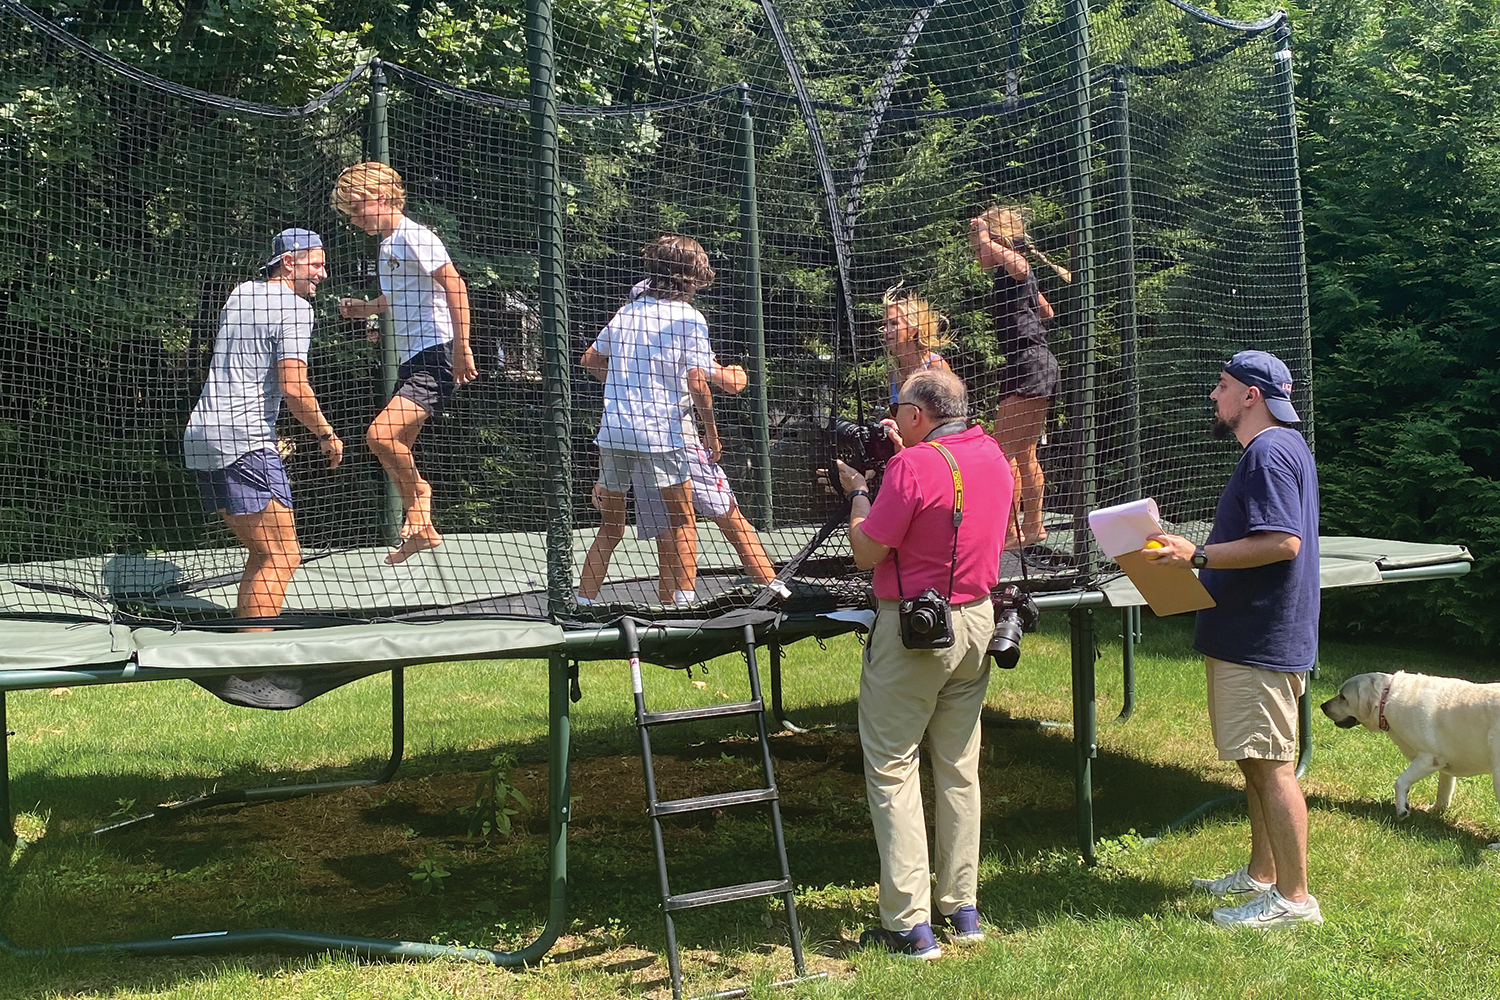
xmin=0 ymin=689 xmax=1260 ymax=985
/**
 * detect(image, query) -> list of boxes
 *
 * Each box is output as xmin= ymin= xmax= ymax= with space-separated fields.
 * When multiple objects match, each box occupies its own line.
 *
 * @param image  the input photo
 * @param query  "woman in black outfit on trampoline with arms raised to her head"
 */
xmin=969 ymin=205 xmax=1073 ymax=546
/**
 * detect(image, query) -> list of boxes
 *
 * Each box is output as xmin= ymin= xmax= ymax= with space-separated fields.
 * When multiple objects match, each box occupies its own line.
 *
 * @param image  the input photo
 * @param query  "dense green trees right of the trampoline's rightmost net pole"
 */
xmin=1299 ymin=0 xmax=1500 ymax=645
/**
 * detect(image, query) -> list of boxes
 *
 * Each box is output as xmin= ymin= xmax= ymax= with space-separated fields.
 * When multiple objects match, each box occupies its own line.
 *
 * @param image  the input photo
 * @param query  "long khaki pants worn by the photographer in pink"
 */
xmin=860 ymin=598 xmax=995 ymax=931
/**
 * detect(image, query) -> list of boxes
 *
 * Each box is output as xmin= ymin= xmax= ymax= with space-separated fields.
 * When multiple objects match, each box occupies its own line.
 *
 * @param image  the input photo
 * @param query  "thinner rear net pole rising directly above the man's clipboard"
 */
xmin=1110 ymin=73 xmax=1142 ymax=499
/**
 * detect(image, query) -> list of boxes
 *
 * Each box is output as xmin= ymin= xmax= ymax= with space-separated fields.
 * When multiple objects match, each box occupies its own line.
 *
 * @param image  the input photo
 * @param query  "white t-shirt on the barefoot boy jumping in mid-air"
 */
xmin=380 ymin=217 xmax=453 ymax=361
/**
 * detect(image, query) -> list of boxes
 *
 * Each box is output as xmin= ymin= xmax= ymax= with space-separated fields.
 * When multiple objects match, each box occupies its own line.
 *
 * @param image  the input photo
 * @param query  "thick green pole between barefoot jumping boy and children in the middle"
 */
xmin=527 ymin=0 xmax=573 ymax=615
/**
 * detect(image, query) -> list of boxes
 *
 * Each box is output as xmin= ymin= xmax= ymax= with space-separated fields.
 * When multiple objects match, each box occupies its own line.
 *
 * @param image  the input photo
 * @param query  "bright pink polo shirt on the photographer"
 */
xmin=861 ymin=427 xmax=1014 ymax=604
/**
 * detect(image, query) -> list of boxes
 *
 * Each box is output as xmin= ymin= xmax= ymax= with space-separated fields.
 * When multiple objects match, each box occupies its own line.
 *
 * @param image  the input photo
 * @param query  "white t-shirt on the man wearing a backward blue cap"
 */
xmin=183 ymin=282 xmax=312 ymax=471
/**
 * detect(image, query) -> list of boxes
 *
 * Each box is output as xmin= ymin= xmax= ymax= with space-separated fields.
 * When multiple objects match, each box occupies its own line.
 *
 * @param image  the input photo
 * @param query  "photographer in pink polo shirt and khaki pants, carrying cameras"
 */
xmin=839 ymin=369 xmax=1014 ymax=958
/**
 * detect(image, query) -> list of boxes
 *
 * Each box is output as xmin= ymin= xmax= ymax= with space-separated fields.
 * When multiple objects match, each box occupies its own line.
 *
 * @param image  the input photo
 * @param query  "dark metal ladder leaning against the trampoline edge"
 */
xmin=620 ymin=618 xmax=824 ymax=1000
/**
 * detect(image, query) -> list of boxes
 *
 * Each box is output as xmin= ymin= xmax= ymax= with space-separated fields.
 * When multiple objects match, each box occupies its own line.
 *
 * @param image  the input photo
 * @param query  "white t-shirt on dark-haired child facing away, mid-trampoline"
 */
xmin=593 ymin=295 xmax=714 ymax=453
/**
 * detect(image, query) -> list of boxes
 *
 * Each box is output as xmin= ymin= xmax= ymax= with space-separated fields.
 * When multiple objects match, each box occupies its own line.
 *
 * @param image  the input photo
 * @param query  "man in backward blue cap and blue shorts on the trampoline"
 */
xmin=183 ymin=229 xmax=344 ymax=629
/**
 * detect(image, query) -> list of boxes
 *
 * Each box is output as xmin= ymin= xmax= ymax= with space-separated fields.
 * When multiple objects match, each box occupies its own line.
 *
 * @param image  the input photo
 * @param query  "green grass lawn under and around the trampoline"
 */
xmin=0 ymin=613 xmax=1500 ymax=1000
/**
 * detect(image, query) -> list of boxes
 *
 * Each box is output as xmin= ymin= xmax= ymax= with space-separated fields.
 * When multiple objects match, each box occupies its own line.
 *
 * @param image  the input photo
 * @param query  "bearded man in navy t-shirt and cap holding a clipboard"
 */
xmin=1142 ymin=351 xmax=1323 ymax=928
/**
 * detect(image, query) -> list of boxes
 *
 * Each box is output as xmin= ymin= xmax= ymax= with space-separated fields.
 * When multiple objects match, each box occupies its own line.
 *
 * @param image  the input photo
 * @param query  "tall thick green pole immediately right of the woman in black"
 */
xmin=1067 ymin=0 xmax=1098 ymax=574
